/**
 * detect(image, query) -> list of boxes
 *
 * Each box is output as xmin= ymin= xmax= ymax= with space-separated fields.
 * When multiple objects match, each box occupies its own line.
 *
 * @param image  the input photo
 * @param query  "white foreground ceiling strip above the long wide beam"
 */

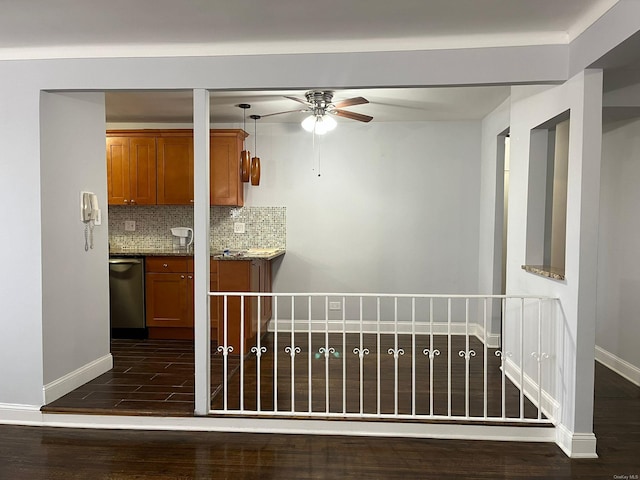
xmin=0 ymin=0 xmax=617 ymax=59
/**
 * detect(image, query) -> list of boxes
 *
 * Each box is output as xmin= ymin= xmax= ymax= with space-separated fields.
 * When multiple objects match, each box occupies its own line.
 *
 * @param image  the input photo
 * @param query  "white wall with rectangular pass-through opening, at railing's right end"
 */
xmin=507 ymin=70 xmax=602 ymax=454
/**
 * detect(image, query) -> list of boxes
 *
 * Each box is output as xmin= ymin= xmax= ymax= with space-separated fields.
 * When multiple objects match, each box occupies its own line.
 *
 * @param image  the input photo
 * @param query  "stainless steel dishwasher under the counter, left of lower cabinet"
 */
xmin=109 ymin=257 xmax=147 ymax=338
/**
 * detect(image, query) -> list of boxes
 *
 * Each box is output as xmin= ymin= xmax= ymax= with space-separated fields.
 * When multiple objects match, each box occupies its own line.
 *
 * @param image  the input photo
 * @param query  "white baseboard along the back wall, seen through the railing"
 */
xmin=269 ymin=320 xmax=500 ymax=348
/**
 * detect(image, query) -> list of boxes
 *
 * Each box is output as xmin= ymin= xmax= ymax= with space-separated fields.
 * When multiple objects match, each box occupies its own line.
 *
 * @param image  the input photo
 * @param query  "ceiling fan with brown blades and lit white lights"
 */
xmin=262 ymin=90 xmax=373 ymax=135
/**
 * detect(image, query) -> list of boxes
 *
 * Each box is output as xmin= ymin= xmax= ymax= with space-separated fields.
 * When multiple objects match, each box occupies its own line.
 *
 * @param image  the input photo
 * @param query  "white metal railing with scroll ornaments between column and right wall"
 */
xmin=210 ymin=292 xmax=558 ymax=424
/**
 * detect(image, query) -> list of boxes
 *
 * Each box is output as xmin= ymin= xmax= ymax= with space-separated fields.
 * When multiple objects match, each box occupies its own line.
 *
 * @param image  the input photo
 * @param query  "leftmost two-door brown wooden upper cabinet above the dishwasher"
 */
xmin=106 ymin=136 xmax=156 ymax=205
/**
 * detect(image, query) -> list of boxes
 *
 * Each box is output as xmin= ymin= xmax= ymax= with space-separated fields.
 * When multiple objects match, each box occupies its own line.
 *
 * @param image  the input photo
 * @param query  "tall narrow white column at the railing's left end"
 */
xmin=193 ymin=88 xmax=211 ymax=415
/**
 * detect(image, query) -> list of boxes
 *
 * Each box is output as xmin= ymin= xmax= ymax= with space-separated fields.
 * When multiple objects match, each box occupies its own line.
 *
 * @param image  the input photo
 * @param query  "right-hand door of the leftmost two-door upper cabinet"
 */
xmin=129 ymin=138 xmax=156 ymax=205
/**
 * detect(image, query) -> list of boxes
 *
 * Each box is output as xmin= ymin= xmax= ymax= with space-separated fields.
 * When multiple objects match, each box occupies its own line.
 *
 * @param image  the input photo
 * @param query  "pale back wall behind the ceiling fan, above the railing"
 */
xmin=246 ymin=122 xmax=480 ymax=293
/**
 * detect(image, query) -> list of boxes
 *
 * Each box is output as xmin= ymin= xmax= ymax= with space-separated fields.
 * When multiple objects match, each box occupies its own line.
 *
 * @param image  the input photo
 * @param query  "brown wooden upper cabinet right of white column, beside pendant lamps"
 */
xmin=210 ymin=130 xmax=247 ymax=207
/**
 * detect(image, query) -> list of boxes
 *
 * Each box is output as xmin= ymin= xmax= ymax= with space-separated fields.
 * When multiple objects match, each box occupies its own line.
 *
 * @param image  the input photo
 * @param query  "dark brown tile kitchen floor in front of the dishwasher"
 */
xmin=42 ymin=339 xmax=237 ymax=416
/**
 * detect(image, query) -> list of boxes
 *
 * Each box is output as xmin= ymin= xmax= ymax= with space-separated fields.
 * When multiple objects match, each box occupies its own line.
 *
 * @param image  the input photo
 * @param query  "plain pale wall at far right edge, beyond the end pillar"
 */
xmin=596 ymin=118 xmax=640 ymax=376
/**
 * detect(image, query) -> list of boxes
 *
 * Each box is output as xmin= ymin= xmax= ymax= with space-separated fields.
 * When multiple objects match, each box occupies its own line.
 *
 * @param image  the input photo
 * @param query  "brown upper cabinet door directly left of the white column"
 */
xmin=157 ymin=136 xmax=193 ymax=205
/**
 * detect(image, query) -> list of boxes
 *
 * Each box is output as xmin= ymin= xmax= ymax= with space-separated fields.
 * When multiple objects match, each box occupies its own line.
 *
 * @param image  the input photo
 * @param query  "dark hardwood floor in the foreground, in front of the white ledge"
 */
xmin=0 ymin=364 xmax=640 ymax=480
